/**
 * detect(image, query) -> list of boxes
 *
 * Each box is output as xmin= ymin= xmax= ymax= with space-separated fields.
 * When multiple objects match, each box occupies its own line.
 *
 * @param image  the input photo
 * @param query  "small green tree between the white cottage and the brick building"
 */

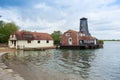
xmin=51 ymin=31 xmax=62 ymax=45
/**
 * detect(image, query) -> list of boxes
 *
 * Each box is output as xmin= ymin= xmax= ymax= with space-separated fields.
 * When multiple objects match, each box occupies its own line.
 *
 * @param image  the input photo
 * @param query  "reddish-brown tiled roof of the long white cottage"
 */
xmin=14 ymin=31 xmax=53 ymax=40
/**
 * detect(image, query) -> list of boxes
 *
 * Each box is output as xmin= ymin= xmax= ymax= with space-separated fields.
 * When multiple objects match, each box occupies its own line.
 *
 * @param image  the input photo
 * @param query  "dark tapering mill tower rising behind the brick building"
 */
xmin=79 ymin=17 xmax=90 ymax=36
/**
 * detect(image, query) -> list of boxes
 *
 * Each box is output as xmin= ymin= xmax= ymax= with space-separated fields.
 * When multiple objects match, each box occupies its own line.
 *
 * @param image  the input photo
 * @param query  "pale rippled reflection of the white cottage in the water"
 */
xmin=3 ymin=51 xmax=51 ymax=65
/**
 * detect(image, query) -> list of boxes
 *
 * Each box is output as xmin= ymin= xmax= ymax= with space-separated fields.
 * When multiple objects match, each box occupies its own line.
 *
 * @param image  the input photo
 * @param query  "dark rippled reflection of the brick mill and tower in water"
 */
xmin=59 ymin=50 xmax=95 ymax=78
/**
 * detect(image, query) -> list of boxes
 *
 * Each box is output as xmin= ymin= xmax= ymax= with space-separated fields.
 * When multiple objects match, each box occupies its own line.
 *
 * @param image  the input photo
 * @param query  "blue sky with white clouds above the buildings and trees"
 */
xmin=0 ymin=0 xmax=120 ymax=39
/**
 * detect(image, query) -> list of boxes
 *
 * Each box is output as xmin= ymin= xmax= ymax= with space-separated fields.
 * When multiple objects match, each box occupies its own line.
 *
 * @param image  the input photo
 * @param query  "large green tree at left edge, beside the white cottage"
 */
xmin=0 ymin=21 xmax=19 ymax=43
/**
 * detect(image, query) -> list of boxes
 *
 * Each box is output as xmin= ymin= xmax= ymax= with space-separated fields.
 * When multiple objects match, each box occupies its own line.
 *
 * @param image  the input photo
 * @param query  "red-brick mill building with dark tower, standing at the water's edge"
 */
xmin=61 ymin=18 xmax=99 ymax=48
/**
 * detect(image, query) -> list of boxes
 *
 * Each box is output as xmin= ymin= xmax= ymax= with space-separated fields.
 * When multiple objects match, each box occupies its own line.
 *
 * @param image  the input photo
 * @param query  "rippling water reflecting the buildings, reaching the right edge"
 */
xmin=3 ymin=42 xmax=120 ymax=80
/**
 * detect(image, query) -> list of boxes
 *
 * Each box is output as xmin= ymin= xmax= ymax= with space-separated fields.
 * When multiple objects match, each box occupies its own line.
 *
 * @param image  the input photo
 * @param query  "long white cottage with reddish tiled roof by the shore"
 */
xmin=8 ymin=31 xmax=53 ymax=49
